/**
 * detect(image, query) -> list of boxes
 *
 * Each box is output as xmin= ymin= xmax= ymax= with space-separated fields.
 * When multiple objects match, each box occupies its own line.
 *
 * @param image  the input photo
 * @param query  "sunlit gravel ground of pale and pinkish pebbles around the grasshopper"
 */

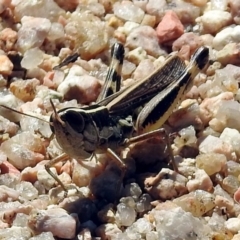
xmin=0 ymin=0 xmax=240 ymax=240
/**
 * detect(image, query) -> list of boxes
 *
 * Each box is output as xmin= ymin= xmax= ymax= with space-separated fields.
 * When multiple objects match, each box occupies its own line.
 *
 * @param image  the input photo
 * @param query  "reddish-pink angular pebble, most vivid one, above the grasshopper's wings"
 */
xmin=156 ymin=11 xmax=184 ymax=43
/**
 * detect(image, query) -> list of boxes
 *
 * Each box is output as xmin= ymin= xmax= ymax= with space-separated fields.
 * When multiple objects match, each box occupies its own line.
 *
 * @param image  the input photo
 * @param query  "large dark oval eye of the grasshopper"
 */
xmin=64 ymin=110 xmax=85 ymax=133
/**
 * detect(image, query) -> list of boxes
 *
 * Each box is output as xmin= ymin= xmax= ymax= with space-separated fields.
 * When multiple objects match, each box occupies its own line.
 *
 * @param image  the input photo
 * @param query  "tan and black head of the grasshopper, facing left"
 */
xmin=50 ymin=100 xmax=98 ymax=158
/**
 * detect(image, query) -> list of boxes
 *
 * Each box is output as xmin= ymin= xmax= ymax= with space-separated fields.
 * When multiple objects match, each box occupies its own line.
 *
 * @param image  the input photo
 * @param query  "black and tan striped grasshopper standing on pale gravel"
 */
xmin=45 ymin=43 xmax=209 ymax=193
